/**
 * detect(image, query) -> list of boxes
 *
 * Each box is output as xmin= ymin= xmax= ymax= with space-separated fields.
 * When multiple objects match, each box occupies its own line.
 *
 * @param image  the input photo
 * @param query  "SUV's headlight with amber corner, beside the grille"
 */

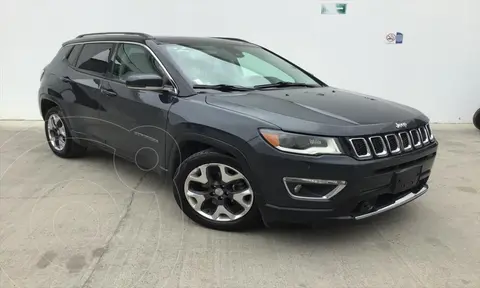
xmin=260 ymin=129 xmax=342 ymax=155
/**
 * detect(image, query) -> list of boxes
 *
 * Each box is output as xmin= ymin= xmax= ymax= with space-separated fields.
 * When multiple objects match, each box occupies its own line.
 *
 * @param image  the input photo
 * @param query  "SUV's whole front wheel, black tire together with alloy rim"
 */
xmin=173 ymin=149 xmax=261 ymax=231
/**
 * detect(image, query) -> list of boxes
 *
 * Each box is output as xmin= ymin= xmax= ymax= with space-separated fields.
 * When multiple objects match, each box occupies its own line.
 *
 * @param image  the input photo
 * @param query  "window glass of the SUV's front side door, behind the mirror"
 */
xmin=112 ymin=44 xmax=163 ymax=81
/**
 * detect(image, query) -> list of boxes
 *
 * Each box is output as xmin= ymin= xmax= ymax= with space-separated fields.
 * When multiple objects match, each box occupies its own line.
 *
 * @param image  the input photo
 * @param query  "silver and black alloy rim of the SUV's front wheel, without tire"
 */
xmin=184 ymin=163 xmax=253 ymax=222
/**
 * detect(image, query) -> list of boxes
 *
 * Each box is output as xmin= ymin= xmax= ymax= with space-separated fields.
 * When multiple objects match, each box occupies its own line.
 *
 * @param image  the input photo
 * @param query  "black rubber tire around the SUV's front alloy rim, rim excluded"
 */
xmin=173 ymin=151 xmax=261 ymax=231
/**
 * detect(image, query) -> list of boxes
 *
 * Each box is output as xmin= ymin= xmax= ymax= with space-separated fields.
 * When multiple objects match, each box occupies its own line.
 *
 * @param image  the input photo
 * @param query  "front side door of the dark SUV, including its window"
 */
xmin=100 ymin=43 xmax=173 ymax=170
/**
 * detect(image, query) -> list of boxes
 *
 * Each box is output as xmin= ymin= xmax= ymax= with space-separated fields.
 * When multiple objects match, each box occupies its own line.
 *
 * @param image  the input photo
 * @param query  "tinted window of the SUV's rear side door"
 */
xmin=76 ymin=43 xmax=113 ymax=75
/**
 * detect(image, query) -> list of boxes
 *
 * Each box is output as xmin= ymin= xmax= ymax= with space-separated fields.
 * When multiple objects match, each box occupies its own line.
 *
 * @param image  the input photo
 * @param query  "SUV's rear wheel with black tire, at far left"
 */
xmin=45 ymin=106 xmax=87 ymax=158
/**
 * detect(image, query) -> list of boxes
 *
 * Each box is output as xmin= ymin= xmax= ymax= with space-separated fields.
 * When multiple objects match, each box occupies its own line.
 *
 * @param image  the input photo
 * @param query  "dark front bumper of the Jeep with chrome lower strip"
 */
xmin=248 ymin=138 xmax=438 ymax=223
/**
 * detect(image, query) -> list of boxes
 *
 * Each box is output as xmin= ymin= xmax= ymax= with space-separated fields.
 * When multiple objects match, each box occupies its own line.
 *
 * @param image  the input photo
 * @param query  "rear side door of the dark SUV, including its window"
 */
xmin=62 ymin=43 xmax=114 ymax=144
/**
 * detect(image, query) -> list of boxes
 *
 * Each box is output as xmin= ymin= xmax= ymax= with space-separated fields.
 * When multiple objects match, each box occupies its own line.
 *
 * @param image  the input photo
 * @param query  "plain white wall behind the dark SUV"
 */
xmin=0 ymin=0 xmax=480 ymax=122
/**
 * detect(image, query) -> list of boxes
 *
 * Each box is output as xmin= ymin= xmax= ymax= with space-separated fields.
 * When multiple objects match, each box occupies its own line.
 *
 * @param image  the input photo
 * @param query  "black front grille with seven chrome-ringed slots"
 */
xmin=348 ymin=125 xmax=434 ymax=160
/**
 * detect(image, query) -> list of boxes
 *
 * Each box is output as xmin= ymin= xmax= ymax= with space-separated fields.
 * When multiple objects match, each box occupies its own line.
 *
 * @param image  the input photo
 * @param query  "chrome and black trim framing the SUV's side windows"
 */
xmin=65 ymin=40 xmax=179 ymax=95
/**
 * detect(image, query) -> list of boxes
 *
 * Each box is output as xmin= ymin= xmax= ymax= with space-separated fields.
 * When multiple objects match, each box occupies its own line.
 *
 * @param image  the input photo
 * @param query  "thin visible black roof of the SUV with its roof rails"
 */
xmin=63 ymin=32 xmax=249 ymax=46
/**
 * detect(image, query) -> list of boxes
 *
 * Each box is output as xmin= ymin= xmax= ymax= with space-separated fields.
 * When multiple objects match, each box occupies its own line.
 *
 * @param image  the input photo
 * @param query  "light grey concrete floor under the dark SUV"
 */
xmin=0 ymin=122 xmax=480 ymax=288
